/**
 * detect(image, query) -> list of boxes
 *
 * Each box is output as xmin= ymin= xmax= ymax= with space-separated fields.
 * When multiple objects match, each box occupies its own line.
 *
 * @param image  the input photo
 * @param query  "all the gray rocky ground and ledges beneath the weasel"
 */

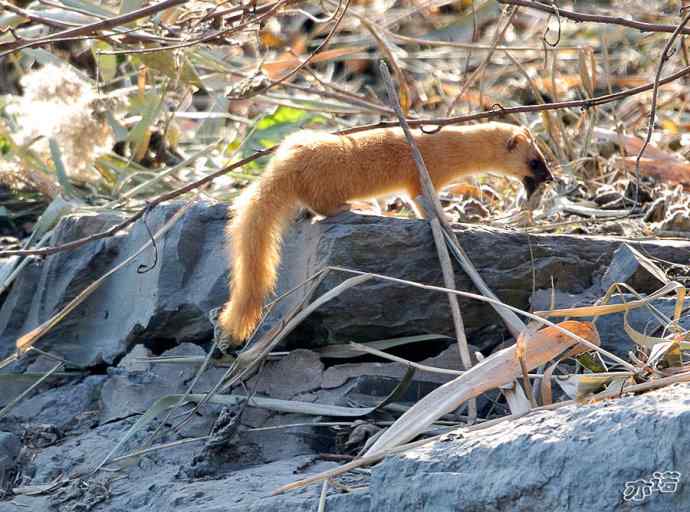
xmin=0 ymin=203 xmax=690 ymax=512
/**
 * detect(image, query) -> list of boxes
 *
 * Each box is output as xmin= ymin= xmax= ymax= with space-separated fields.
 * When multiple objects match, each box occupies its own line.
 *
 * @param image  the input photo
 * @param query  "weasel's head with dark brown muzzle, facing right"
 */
xmin=504 ymin=127 xmax=553 ymax=198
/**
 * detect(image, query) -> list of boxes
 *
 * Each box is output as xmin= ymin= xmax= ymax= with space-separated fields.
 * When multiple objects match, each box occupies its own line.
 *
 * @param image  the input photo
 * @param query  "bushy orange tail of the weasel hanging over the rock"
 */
xmin=218 ymin=161 xmax=299 ymax=340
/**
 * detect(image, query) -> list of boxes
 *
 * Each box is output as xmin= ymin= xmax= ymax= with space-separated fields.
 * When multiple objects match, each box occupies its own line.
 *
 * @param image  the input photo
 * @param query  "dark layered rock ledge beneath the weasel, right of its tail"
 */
xmin=281 ymin=214 xmax=690 ymax=350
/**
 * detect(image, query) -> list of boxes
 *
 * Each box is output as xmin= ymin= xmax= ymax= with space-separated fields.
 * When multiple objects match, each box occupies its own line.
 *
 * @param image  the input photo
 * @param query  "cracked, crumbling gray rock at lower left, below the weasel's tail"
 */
xmin=0 ymin=343 xmax=457 ymax=512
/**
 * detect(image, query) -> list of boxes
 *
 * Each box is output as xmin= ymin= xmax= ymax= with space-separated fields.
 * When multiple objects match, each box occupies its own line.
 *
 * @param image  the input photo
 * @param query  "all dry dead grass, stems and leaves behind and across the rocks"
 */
xmin=0 ymin=0 xmax=690 ymax=504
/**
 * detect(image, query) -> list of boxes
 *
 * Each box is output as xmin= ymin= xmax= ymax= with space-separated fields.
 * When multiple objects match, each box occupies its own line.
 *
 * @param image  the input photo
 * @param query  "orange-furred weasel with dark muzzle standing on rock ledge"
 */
xmin=219 ymin=123 xmax=553 ymax=345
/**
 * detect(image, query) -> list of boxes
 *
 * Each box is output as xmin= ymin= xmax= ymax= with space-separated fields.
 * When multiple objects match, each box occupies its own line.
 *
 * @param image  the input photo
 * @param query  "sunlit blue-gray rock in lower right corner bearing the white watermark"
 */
xmin=362 ymin=384 xmax=690 ymax=512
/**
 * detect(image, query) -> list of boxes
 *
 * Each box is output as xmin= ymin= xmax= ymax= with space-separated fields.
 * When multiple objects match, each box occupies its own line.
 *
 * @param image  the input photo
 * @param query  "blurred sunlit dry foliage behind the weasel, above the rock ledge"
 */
xmin=0 ymin=0 xmax=690 ymax=247
